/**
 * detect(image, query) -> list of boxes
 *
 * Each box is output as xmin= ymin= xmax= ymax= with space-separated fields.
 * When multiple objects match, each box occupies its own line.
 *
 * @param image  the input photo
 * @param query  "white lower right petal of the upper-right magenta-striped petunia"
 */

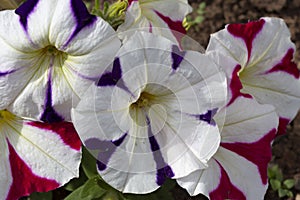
xmin=241 ymin=64 xmax=300 ymax=134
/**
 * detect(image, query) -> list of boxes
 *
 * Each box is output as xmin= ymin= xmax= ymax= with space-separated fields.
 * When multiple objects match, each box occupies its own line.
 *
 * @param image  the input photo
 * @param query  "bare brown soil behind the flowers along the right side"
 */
xmin=173 ymin=0 xmax=300 ymax=200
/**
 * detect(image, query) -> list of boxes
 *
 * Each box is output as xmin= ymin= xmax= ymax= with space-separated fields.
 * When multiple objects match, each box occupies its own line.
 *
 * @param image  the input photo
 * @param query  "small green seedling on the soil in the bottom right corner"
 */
xmin=268 ymin=165 xmax=295 ymax=198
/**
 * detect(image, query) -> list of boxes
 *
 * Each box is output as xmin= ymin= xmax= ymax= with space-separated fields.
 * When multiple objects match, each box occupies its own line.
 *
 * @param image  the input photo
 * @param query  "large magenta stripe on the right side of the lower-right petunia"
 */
xmin=221 ymin=129 xmax=276 ymax=184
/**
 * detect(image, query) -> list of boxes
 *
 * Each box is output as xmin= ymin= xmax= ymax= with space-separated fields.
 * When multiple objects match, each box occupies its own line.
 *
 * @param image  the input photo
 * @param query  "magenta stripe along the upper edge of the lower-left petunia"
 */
xmin=27 ymin=122 xmax=81 ymax=151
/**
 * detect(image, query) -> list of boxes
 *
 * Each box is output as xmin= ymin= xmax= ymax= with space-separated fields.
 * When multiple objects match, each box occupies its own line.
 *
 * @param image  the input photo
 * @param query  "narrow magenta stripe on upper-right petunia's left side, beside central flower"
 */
xmin=227 ymin=65 xmax=252 ymax=106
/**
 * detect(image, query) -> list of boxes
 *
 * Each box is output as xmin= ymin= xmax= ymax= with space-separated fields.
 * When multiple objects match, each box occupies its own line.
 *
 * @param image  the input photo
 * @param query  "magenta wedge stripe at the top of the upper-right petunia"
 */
xmin=227 ymin=19 xmax=265 ymax=60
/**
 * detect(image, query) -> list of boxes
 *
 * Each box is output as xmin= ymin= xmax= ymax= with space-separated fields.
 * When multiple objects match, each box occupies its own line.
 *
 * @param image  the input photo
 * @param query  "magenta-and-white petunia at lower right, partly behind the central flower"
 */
xmin=177 ymin=96 xmax=278 ymax=200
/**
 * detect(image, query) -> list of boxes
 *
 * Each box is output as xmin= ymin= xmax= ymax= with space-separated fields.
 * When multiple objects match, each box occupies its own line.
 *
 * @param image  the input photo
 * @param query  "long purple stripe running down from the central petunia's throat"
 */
xmin=146 ymin=117 xmax=175 ymax=185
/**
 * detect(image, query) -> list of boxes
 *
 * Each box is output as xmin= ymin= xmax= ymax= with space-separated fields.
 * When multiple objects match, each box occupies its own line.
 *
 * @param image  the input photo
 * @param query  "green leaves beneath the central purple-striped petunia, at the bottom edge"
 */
xmin=64 ymin=147 xmax=176 ymax=200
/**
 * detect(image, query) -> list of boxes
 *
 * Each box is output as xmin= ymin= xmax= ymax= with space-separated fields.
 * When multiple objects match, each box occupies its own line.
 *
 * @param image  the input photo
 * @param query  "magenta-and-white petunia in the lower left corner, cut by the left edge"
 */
xmin=0 ymin=110 xmax=81 ymax=200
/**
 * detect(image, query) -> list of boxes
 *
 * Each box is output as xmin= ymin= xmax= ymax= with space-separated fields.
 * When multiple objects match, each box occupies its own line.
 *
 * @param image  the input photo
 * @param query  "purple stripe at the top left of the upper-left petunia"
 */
xmin=15 ymin=0 xmax=39 ymax=31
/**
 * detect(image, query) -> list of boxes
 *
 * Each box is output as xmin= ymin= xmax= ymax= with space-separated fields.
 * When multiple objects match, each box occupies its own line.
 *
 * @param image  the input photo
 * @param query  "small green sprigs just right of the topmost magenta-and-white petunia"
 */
xmin=183 ymin=2 xmax=206 ymax=31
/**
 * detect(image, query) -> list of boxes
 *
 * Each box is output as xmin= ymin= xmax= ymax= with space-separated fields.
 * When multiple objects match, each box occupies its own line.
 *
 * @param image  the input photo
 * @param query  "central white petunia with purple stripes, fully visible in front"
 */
xmin=72 ymin=32 xmax=227 ymax=193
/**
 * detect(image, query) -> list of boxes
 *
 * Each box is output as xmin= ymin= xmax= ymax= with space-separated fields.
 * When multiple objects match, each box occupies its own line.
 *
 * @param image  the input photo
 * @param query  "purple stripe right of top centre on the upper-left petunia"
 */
xmin=64 ymin=0 xmax=97 ymax=46
